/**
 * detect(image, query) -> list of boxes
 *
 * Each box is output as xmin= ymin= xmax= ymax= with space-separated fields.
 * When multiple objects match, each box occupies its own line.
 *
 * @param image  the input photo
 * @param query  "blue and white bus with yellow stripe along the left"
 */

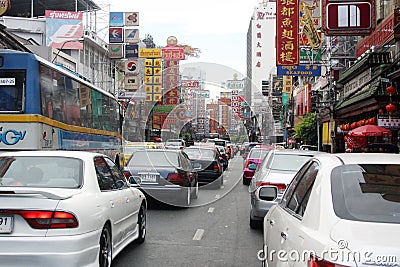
xmin=0 ymin=50 xmax=123 ymax=166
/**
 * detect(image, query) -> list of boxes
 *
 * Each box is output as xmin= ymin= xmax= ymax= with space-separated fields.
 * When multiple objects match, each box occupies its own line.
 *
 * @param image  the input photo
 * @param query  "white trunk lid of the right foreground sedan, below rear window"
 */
xmin=330 ymin=220 xmax=400 ymax=267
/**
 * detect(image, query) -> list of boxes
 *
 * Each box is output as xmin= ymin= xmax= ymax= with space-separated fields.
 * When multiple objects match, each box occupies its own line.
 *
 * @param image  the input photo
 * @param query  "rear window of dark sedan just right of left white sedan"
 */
xmin=127 ymin=150 xmax=179 ymax=167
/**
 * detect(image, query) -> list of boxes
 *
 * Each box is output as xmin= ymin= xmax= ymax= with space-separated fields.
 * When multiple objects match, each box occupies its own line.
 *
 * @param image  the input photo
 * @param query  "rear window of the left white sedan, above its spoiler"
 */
xmin=0 ymin=156 xmax=83 ymax=189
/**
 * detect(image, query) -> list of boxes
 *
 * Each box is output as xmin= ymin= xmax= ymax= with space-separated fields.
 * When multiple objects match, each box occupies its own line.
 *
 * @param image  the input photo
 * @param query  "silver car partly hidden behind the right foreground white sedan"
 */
xmin=249 ymin=149 xmax=324 ymax=228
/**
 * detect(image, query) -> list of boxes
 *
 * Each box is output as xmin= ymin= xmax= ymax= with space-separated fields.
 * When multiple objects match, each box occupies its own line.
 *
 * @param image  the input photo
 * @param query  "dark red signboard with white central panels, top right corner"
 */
xmin=322 ymin=0 xmax=375 ymax=36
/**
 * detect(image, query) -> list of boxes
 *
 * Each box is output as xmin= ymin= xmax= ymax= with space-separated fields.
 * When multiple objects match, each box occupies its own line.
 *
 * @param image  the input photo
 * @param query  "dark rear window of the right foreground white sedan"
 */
xmin=331 ymin=164 xmax=400 ymax=223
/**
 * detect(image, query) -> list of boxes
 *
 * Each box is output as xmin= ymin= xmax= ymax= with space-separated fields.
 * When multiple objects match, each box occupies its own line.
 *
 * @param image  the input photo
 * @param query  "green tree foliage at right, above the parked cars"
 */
xmin=294 ymin=112 xmax=318 ymax=145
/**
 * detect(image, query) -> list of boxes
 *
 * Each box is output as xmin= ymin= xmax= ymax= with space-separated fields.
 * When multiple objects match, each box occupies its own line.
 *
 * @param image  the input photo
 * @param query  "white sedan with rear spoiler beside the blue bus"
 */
xmin=0 ymin=151 xmax=147 ymax=266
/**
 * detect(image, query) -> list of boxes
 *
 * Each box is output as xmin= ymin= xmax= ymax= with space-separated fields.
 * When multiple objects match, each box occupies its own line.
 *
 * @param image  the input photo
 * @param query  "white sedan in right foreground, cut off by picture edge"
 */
xmin=258 ymin=153 xmax=400 ymax=267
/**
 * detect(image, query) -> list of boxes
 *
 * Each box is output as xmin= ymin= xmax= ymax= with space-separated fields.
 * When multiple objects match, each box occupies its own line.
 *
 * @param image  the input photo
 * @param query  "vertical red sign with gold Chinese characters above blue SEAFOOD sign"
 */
xmin=276 ymin=0 xmax=300 ymax=66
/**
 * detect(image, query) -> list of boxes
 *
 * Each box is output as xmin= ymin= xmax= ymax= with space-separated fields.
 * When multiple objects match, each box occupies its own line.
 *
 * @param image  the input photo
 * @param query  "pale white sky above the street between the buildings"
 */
xmin=94 ymin=0 xmax=262 ymax=77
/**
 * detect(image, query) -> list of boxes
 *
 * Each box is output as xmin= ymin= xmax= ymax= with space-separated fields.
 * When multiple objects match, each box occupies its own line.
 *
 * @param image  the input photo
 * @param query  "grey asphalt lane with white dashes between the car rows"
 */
xmin=113 ymin=156 xmax=262 ymax=266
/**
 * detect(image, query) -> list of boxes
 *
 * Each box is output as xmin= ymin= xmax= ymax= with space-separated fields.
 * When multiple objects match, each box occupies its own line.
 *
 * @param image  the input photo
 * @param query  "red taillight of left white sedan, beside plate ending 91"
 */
xmin=5 ymin=210 xmax=79 ymax=229
